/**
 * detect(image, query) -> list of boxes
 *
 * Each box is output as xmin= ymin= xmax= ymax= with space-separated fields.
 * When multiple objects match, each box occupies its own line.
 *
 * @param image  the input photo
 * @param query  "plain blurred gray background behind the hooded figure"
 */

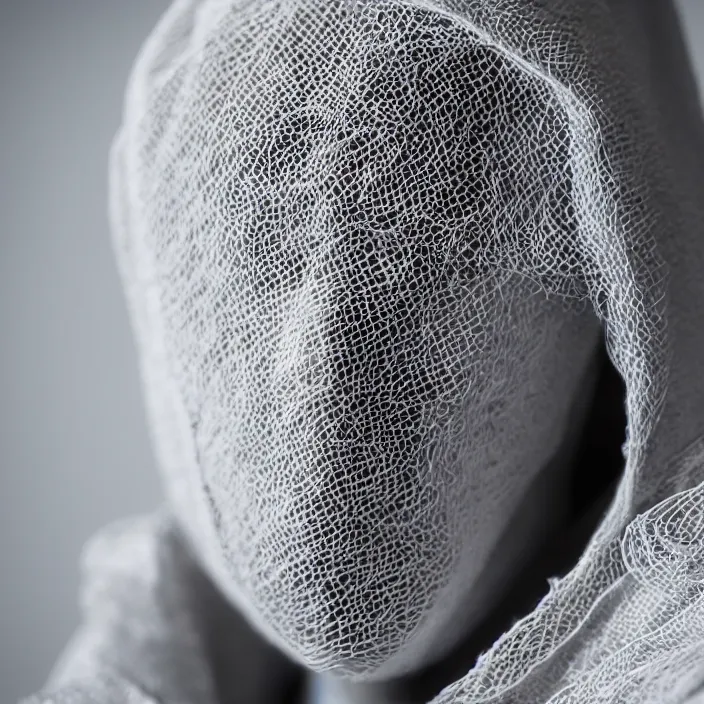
xmin=0 ymin=0 xmax=704 ymax=704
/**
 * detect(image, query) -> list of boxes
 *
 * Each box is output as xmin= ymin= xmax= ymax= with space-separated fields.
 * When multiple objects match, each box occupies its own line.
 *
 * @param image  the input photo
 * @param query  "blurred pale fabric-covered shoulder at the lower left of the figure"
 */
xmin=22 ymin=511 xmax=215 ymax=704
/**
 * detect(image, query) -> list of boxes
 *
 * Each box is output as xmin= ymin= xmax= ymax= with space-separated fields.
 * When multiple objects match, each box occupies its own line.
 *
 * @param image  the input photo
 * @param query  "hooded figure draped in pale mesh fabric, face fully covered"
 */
xmin=20 ymin=0 xmax=704 ymax=704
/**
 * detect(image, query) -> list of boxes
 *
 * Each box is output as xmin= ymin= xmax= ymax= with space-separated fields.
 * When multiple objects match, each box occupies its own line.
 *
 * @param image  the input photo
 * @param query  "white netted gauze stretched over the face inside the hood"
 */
xmin=113 ymin=2 xmax=598 ymax=677
